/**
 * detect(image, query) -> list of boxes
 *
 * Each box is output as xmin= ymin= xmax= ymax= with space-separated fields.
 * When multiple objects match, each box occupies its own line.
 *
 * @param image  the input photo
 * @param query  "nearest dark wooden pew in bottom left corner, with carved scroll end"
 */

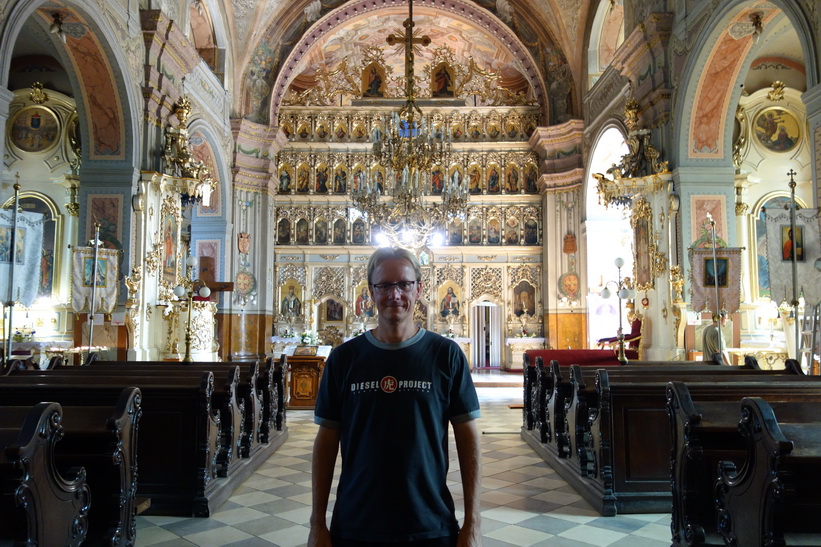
xmin=0 ymin=400 xmax=90 ymax=547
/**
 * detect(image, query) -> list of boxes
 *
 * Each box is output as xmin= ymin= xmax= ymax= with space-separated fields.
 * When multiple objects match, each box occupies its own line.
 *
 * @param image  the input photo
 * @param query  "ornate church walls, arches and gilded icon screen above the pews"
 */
xmin=0 ymin=0 xmax=821 ymax=545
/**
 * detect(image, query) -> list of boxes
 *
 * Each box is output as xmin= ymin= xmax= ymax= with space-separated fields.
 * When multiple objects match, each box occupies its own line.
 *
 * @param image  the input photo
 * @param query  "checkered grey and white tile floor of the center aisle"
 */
xmin=137 ymin=388 xmax=670 ymax=547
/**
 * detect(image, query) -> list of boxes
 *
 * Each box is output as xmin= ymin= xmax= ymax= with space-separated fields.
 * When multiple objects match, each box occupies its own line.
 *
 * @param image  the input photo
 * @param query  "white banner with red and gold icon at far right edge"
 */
xmin=766 ymin=209 xmax=821 ymax=306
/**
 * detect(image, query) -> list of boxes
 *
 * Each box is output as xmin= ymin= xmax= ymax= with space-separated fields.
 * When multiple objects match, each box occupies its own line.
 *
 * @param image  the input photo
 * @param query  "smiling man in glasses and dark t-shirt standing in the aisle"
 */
xmin=308 ymin=248 xmax=482 ymax=547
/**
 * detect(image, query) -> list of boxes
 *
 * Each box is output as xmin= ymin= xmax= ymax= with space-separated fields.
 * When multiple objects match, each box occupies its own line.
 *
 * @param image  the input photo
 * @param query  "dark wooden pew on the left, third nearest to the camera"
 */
xmin=0 ymin=371 xmax=223 ymax=516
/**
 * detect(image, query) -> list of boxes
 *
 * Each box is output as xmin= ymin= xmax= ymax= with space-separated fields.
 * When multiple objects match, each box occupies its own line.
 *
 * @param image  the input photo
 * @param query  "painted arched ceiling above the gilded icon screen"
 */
xmin=234 ymin=0 xmax=584 ymax=123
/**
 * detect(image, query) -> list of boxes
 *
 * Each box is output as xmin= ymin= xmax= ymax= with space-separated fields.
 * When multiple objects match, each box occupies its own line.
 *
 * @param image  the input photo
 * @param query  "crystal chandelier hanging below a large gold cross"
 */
xmin=352 ymin=0 xmax=470 ymax=248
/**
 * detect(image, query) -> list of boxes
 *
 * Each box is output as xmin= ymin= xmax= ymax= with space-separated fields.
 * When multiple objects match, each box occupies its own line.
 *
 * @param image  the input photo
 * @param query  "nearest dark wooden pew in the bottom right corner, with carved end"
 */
xmin=716 ymin=397 xmax=821 ymax=546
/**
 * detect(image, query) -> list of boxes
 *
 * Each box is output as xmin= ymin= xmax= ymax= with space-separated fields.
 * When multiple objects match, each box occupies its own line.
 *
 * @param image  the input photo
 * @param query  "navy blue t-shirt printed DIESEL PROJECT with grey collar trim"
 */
xmin=314 ymin=329 xmax=479 ymax=542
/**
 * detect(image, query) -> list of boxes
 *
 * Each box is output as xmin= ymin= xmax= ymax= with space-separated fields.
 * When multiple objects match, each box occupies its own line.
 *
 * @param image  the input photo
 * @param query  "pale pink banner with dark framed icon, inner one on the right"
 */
xmin=690 ymin=247 xmax=742 ymax=313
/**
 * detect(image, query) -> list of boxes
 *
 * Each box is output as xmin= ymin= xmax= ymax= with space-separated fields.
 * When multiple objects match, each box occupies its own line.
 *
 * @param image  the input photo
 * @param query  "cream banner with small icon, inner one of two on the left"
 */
xmin=71 ymin=247 xmax=120 ymax=313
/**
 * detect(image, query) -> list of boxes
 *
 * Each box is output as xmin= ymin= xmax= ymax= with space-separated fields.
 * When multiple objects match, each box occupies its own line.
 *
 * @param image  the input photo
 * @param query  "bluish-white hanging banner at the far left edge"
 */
xmin=0 ymin=209 xmax=44 ymax=307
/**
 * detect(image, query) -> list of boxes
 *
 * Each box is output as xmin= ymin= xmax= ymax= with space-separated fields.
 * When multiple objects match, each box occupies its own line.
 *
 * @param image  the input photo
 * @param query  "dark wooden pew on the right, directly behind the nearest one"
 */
xmin=667 ymin=382 xmax=821 ymax=545
